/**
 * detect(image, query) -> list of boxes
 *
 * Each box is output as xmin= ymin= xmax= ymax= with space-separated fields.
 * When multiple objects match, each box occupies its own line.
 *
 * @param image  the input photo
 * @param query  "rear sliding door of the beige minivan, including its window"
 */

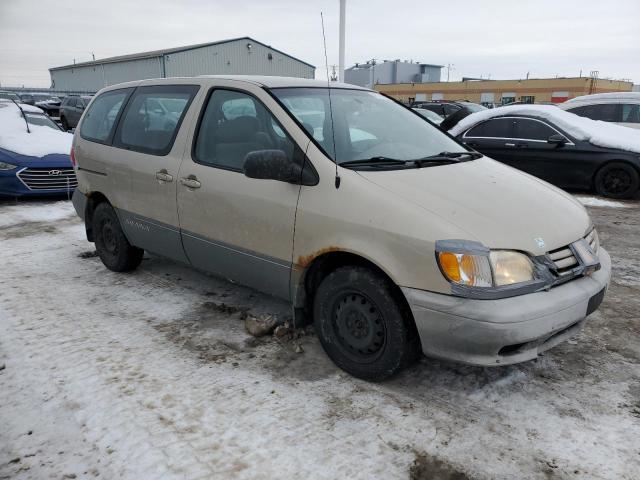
xmin=111 ymin=85 xmax=198 ymax=262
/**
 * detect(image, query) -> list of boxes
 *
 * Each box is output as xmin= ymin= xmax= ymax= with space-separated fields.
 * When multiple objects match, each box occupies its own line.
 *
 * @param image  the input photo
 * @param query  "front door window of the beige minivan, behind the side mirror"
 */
xmin=193 ymin=89 xmax=299 ymax=171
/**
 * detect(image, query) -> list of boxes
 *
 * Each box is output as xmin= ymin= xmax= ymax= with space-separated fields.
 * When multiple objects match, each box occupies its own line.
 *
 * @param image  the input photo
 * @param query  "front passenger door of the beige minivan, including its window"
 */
xmin=178 ymin=88 xmax=301 ymax=299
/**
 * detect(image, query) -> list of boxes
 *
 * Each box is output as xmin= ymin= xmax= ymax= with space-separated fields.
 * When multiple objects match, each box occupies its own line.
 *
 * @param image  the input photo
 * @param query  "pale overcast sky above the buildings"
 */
xmin=0 ymin=0 xmax=640 ymax=87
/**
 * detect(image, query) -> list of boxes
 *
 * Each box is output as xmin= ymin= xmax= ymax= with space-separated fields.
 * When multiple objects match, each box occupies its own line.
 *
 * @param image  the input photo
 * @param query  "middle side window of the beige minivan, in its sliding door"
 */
xmin=114 ymin=85 xmax=199 ymax=155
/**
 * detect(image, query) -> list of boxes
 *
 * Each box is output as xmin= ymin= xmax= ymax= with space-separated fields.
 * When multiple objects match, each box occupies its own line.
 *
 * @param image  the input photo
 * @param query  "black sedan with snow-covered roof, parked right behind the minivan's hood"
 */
xmin=449 ymin=106 xmax=640 ymax=201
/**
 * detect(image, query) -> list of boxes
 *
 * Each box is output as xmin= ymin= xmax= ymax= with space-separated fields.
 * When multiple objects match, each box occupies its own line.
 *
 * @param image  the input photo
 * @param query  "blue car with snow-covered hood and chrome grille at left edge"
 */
xmin=0 ymin=101 xmax=77 ymax=197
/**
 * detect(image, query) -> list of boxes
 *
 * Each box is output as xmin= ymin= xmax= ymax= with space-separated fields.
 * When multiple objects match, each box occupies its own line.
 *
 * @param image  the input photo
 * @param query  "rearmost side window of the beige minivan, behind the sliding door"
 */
xmin=80 ymin=88 xmax=133 ymax=143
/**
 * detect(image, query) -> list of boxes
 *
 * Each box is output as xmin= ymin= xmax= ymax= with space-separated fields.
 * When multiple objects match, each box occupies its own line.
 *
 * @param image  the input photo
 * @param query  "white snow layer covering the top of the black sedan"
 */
xmin=449 ymin=105 xmax=640 ymax=153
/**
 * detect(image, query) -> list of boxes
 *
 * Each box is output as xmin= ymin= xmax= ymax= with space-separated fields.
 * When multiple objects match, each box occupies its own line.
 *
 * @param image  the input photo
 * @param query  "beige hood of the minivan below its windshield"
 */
xmin=358 ymin=157 xmax=591 ymax=255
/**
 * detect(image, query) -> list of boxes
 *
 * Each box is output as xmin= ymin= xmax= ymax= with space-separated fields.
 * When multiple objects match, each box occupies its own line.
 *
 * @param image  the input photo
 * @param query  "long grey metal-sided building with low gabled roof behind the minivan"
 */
xmin=49 ymin=37 xmax=315 ymax=92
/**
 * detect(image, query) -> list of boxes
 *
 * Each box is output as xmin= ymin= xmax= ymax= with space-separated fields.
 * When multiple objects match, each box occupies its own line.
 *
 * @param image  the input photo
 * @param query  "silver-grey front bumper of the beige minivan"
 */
xmin=402 ymin=248 xmax=611 ymax=366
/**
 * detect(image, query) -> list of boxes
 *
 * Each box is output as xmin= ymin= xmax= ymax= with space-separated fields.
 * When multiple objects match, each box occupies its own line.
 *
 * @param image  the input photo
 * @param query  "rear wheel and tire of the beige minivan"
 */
xmin=93 ymin=202 xmax=144 ymax=272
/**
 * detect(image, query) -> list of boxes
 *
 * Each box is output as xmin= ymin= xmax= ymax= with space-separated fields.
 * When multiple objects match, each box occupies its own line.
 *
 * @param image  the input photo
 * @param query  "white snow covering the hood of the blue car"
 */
xmin=0 ymin=101 xmax=73 ymax=157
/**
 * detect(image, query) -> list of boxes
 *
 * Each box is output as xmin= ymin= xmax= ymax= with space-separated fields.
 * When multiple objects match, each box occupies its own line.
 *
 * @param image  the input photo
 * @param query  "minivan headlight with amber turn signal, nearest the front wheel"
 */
xmin=437 ymin=241 xmax=536 ymax=288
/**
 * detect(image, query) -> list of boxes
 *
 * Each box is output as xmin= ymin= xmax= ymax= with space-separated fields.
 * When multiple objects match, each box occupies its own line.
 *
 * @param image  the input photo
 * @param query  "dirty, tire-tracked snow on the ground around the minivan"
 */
xmin=0 ymin=202 xmax=640 ymax=480
